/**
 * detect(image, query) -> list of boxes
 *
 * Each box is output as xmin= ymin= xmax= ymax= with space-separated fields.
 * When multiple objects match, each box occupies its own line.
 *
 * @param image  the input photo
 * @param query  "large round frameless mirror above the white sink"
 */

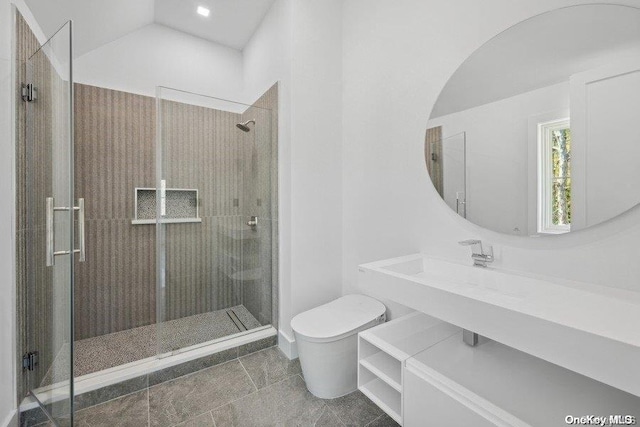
xmin=425 ymin=4 xmax=640 ymax=236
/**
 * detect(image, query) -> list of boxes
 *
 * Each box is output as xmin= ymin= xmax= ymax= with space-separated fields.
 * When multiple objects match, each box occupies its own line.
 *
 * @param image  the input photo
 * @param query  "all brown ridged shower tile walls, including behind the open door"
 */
xmin=15 ymin=7 xmax=278 ymax=397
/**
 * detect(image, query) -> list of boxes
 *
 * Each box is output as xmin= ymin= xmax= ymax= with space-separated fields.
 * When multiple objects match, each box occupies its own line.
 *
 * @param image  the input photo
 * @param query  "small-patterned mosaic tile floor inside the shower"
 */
xmin=41 ymin=305 xmax=262 ymax=386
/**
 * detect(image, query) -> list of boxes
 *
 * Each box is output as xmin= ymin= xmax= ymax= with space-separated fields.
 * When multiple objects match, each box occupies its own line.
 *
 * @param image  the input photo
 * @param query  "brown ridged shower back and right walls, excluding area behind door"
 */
xmin=75 ymin=84 xmax=277 ymax=339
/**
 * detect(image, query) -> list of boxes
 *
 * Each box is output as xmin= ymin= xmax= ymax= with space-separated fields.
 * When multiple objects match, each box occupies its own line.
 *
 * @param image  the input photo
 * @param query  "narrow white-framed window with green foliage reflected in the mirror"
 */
xmin=538 ymin=119 xmax=571 ymax=234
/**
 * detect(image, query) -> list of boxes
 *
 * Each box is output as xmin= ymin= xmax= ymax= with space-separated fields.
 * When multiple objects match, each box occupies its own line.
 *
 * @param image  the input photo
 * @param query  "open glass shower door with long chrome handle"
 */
xmin=21 ymin=22 xmax=75 ymax=425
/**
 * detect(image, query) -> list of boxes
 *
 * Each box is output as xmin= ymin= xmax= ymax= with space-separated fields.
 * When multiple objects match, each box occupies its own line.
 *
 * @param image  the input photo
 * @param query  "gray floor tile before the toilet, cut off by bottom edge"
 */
xmin=213 ymin=375 xmax=325 ymax=427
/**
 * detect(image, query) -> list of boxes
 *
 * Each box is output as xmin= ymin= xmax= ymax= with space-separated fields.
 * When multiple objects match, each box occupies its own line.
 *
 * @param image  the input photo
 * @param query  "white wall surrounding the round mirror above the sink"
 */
xmin=343 ymin=0 xmax=640 ymax=314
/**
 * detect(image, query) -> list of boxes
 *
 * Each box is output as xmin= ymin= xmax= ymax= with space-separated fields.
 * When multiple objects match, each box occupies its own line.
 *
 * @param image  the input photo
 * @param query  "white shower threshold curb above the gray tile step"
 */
xmin=20 ymin=325 xmax=278 ymax=412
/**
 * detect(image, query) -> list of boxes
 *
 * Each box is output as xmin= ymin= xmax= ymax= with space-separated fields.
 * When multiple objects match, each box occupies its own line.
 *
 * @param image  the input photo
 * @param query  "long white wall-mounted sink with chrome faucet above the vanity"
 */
xmin=359 ymin=254 xmax=640 ymax=396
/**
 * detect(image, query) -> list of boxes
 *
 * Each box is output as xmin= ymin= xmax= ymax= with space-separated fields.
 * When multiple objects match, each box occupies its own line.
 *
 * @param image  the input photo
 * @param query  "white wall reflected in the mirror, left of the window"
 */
xmin=427 ymin=81 xmax=569 ymax=235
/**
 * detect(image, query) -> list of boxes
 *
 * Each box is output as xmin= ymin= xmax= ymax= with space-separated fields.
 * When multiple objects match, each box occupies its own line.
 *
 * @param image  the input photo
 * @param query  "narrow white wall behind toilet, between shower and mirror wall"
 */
xmin=288 ymin=0 xmax=343 ymax=338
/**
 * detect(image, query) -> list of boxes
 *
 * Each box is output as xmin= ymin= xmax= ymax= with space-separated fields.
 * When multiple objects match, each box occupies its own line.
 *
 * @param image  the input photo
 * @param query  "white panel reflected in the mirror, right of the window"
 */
xmin=571 ymin=63 xmax=640 ymax=230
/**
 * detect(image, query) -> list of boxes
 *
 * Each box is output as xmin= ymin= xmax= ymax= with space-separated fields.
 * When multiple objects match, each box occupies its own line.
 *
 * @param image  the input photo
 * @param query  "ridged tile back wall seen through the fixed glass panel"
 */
xmin=160 ymin=100 xmax=242 ymax=326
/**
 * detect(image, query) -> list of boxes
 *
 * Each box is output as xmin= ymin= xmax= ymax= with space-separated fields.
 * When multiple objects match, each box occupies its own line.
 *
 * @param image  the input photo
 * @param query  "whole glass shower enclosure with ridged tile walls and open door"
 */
xmin=16 ymin=11 xmax=277 ymax=425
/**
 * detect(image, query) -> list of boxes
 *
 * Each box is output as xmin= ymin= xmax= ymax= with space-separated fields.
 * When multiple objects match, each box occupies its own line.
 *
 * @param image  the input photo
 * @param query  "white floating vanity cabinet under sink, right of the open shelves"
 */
xmin=403 ymin=332 xmax=640 ymax=427
